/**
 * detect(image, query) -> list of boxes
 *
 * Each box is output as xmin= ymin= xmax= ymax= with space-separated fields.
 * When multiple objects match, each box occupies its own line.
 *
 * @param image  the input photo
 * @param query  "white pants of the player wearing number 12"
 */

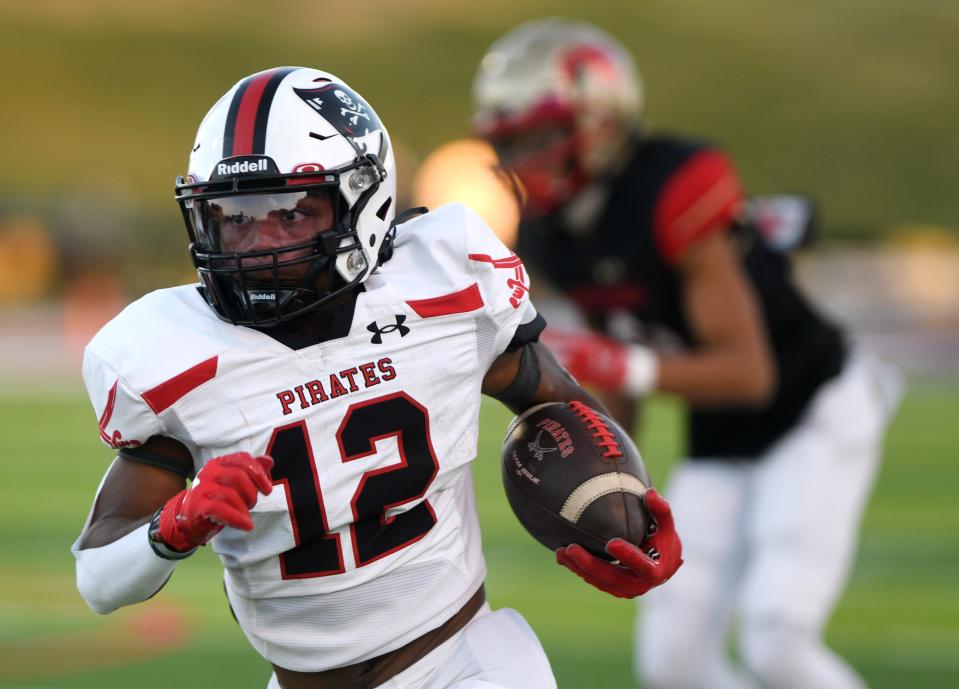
xmin=267 ymin=605 xmax=556 ymax=689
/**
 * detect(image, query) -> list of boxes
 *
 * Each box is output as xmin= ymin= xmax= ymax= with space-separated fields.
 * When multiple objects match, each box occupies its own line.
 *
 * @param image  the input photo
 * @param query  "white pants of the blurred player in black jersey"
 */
xmin=636 ymin=354 xmax=902 ymax=689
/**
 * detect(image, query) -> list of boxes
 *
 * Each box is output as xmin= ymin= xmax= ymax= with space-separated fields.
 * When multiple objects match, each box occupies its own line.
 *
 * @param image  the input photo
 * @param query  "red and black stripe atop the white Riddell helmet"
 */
xmin=223 ymin=67 xmax=297 ymax=158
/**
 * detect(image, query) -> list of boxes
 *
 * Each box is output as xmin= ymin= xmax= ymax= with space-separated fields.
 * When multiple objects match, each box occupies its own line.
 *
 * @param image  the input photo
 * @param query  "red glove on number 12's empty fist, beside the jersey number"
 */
xmin=157 ymin=452 xmax=273 ymax=551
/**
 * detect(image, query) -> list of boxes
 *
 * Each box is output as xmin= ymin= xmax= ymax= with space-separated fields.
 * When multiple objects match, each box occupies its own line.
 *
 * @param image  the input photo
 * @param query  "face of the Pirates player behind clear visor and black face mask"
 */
xmin=209 ymin=189 xmax=334 ymax=281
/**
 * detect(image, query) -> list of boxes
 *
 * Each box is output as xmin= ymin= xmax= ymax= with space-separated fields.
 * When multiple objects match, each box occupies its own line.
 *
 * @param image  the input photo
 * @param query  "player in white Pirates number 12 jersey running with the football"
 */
xmin=73 ymin=68 xmax=681 ymax=689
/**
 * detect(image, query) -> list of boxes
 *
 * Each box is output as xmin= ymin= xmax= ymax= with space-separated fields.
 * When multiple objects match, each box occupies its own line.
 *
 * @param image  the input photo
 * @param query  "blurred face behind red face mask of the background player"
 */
xmin=492 ymin=123 xmax=576 ymax=213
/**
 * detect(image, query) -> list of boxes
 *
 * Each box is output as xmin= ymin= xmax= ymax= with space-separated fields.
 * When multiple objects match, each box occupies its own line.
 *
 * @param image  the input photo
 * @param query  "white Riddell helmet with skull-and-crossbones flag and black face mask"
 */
xmin=176 ymin=67 xmax=396 ymax=327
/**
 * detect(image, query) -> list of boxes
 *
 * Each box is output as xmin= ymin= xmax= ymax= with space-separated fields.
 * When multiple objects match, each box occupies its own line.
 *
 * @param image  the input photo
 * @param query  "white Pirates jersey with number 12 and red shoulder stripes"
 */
xmin=83 ymin=204 xmax=536 ymax=671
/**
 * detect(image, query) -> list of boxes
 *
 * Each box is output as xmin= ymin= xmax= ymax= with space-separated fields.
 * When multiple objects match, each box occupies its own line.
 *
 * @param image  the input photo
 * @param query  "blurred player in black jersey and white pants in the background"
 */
xmin=474 ymin=19 xmax=900 ymax=689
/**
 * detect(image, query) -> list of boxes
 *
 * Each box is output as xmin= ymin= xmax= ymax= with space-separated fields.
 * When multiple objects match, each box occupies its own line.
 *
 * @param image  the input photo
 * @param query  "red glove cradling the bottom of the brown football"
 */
xmin=556 ymin=488 xmax=683 ymax=598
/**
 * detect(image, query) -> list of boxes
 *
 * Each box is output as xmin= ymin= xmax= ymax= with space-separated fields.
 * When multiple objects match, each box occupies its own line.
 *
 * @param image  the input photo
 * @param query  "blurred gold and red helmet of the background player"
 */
xmin=473 ymin=18 xmax=643 ymax=212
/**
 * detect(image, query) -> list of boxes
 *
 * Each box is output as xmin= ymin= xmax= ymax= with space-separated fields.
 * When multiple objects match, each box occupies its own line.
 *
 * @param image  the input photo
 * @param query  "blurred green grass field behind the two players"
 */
xmin=0 ymin=386 xmax=959 ymax=689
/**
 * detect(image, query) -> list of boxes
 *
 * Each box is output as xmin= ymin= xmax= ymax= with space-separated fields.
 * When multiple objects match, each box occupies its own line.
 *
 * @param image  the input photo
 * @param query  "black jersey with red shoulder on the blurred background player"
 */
xmin=518 ymin=136 xmax=845 ymax=458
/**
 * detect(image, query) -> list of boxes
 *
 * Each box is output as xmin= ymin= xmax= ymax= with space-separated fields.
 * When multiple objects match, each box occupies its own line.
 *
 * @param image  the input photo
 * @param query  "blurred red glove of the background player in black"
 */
xmin=540 ymin=328 xmax=628 ymax=392
